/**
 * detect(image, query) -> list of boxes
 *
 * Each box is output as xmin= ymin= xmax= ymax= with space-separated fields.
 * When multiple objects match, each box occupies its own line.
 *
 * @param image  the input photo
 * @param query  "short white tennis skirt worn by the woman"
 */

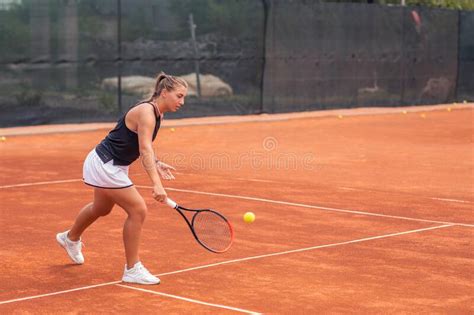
xmin=82 ymin=149 xmax=133 ymax=189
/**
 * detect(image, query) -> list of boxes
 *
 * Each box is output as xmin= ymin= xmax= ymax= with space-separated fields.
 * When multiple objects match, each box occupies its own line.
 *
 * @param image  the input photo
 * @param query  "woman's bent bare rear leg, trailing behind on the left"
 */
xmin=68 ymin=188 xmax=114 ymax=241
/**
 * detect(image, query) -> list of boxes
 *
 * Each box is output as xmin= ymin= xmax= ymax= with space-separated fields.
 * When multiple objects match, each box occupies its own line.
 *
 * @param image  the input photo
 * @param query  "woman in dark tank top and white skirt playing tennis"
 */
xmin=56 ymin=72 xmax=188 ymax=284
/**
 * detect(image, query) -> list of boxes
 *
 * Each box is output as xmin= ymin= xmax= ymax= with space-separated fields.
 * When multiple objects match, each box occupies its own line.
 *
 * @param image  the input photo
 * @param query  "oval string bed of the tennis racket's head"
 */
xmin=193 ymin=211 xmax=232 ymax=252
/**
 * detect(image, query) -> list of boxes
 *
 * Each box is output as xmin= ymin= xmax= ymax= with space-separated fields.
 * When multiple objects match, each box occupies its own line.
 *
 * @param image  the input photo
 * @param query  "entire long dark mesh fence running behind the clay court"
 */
xmin=0 ymin=0 xmax=474 ymax=127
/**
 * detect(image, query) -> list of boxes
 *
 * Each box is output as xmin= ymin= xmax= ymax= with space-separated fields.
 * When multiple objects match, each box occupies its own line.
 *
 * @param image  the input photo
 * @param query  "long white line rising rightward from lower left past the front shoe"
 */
xmin=0 ymin=224 xmax=455 ymax=305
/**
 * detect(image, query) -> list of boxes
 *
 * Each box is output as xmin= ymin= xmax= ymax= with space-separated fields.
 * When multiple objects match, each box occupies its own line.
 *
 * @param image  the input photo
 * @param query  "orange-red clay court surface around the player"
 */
xmin=0 ymin=108 xmax=474 ymax=314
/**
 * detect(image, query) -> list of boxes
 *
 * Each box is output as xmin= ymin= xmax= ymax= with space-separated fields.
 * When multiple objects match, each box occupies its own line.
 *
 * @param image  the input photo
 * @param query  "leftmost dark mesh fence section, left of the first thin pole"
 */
xmin=0 ymin=0 xmax=118 ymax=126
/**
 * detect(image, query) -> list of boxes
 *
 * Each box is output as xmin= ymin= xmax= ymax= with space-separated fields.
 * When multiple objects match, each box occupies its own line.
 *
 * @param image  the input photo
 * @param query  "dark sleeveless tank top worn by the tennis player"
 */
xmin=95 ymin=103 xmax=161 ymax=165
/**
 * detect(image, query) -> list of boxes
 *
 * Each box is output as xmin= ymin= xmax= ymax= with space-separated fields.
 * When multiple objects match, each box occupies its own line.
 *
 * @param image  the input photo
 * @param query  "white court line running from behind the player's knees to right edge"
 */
xmin=136 ymin=185 xmax=474 ymax=227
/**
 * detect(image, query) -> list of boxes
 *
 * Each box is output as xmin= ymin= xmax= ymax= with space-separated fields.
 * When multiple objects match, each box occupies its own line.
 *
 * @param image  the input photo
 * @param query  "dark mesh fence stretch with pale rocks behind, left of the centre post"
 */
xmin=0 ymin=0 xmax=264 ymax=127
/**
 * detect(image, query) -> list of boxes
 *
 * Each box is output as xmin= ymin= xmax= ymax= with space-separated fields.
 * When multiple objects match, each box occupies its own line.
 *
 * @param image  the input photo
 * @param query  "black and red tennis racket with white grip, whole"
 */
xmin=166 ymin=198 xmax=234 ymax=253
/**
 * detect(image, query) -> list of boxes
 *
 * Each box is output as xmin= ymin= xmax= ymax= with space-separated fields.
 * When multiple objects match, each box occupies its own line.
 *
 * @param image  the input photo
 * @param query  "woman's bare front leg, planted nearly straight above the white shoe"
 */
xmin=106 ymin=186 xmax=147 ymax=268
